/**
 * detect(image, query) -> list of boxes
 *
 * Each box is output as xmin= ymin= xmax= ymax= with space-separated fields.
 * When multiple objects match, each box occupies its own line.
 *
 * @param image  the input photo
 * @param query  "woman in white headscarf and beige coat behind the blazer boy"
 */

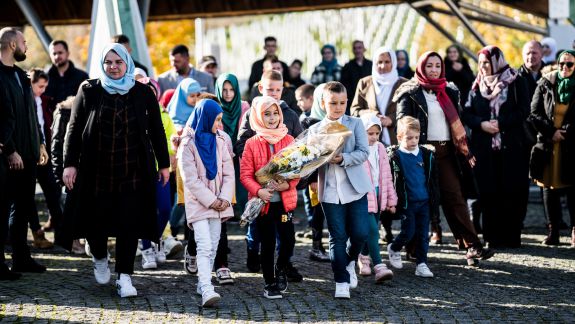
xmin=350 ymin=47 xmax=407 ymax=146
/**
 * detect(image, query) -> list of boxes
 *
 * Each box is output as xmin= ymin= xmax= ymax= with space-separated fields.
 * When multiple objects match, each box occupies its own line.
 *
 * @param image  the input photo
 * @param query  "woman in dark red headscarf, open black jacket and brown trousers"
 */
xmin=393 ymin=52 xmax=493 ymax=264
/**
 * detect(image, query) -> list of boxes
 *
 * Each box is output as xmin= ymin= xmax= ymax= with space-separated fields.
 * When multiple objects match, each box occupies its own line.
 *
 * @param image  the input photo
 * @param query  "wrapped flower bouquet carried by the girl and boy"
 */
xmin=240 ymin=122 xmax=351 ymax=226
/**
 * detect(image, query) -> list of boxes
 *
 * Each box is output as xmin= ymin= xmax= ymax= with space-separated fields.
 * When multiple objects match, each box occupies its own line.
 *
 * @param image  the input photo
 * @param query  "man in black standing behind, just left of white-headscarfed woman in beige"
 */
xmin=341 ymin=40 xmax=373 ymax=115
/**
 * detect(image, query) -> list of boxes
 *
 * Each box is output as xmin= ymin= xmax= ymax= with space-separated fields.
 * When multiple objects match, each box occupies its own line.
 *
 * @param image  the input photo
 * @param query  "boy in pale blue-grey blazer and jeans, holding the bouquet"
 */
xmin=310 ymin=81 xmax=372 ymax=298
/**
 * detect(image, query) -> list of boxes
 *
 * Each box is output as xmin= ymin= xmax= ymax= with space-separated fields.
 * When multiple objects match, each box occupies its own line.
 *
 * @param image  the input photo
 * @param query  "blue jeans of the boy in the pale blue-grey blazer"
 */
xmin=321 ymin=195 xmax=370 ymax=283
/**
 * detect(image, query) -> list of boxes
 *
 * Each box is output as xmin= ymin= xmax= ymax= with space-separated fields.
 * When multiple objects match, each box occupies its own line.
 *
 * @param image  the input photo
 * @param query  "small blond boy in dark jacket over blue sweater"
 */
xmin=387 ymin=116 xmax=439 ymax=278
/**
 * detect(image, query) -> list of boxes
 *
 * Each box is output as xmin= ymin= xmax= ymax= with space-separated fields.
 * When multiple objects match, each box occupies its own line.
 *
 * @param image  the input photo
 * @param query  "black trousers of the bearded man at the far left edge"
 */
xmin=2 ymin=160 xmax=36 ymax=262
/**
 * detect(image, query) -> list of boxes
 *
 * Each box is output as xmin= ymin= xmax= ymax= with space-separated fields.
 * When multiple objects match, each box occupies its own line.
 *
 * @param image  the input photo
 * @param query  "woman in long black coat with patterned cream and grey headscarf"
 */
xmin=463 ymin=46 xmax=529 ymax=248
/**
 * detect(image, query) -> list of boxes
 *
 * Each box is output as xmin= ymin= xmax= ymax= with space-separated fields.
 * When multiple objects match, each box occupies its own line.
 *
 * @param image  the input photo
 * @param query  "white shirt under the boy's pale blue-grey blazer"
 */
xmin=321 ymin=116 xmax=365 ymax=204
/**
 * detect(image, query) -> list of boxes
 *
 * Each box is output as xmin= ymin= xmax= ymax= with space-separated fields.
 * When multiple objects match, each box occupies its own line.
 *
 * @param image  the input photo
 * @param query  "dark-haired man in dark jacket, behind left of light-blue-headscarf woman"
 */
xmin=44 ymin=40 xmax=88 ymax=110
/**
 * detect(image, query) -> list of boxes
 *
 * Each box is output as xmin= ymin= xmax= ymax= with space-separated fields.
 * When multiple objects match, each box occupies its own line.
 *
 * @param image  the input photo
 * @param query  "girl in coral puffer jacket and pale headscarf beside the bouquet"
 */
xmin=240 ymin=96 xmax=298 ymax=299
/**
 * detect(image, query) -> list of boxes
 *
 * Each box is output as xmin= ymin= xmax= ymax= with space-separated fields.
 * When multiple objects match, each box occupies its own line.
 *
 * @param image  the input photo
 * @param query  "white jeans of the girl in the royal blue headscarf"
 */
xmin=192 ymin=218 xmax=222 ymax=292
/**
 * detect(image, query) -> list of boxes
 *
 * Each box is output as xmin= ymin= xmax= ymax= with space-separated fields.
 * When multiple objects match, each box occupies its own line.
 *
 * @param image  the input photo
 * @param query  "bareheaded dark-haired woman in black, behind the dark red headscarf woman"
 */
xmin=445 ymin=45 xmax=475 ymax=105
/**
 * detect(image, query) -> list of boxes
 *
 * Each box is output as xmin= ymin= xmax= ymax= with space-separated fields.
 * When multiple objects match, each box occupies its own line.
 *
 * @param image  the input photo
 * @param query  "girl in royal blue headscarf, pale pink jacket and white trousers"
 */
xmin=178 ymin=99 xmax=235 ymax=307
